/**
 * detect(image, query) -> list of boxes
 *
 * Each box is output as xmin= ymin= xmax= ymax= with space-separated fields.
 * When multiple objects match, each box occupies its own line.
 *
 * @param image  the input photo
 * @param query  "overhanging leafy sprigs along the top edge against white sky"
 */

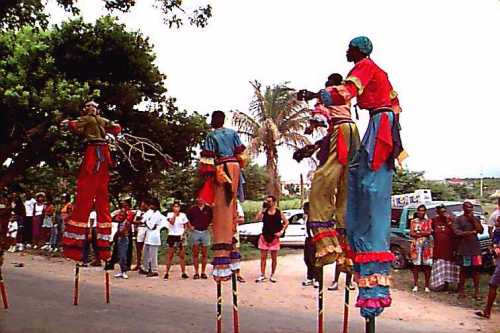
xmin=0 ymin=0 xmax=212 ymax=29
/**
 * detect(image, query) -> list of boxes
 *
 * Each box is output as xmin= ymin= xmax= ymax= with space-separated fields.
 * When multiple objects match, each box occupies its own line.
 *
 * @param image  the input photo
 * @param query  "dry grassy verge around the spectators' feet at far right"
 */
xmin=392 ymin=269 xmax=500 ymax=312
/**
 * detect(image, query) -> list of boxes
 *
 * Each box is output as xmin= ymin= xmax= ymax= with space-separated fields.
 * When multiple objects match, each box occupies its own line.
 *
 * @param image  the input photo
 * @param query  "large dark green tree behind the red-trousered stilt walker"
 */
xmin=0 ymin=17 xmax=207 ymax=194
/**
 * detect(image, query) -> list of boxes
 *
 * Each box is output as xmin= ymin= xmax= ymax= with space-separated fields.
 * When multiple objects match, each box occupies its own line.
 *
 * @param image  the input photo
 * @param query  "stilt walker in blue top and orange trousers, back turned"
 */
xmin=198 ymin=111 xmax=245 ymax=332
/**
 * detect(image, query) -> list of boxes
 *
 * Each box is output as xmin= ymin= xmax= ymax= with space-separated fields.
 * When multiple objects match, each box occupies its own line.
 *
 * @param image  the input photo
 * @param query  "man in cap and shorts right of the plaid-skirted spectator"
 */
xmin=453 ymin=201 xmax=484 ymax=299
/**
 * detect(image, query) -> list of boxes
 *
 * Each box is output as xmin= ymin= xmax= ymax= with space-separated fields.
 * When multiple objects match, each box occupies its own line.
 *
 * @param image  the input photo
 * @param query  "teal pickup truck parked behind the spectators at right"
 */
xmin=390 ymin=201 xmax=492 ymax=269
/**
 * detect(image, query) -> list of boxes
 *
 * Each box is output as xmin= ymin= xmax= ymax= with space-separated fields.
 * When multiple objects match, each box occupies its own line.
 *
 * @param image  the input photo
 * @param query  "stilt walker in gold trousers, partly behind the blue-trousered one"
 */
xmin=293 ymin=73 xmax=359 ymax=332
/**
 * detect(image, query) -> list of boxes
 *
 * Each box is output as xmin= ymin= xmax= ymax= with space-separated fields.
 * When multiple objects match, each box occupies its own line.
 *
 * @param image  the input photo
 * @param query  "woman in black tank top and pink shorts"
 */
xmin=255 ymin=195 xmax=288 ymax=283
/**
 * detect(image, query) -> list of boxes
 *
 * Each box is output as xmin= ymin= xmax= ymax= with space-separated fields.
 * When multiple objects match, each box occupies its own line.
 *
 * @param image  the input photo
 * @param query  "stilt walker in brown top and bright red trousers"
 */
xmin=62 ymin=101 xmax=121 ymax=304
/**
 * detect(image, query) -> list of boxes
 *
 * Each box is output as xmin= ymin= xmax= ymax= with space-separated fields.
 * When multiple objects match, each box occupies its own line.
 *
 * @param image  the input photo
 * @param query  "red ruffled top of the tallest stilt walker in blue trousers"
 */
xmin=326 ymin=58 xmax=401 ymax=113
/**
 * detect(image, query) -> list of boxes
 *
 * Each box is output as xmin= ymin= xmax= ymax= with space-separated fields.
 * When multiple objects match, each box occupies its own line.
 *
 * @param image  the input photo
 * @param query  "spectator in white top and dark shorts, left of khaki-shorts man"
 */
xmin=163 ymin=201 xmax=189 ymax=280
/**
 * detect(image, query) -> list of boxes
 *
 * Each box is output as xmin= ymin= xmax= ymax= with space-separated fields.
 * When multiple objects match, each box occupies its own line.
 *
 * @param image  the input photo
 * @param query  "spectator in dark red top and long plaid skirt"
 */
xmin=431 ymin=205 xmax=460 ymax=291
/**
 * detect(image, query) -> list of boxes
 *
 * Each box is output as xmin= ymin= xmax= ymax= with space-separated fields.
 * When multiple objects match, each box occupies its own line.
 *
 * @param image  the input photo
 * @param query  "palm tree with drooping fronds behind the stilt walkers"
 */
xmin=233 ymin=81 xmax=310 ymax=198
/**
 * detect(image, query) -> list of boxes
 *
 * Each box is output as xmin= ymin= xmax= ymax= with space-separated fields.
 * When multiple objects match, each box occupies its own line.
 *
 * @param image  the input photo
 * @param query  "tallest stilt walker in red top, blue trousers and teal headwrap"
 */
xmin=303 ymin=36 xmax=405 ymax=333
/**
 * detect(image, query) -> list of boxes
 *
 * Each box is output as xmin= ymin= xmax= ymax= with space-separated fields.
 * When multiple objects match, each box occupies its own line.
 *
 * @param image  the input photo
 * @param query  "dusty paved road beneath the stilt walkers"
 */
xmin=0 ymin=253 xmax=494 ymax=333
